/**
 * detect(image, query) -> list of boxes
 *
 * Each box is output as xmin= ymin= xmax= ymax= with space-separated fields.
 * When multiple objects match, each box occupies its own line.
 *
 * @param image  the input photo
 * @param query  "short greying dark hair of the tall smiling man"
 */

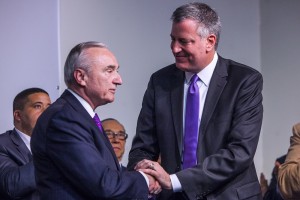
xmin=171 ymin=2 xmax=221 ymax=49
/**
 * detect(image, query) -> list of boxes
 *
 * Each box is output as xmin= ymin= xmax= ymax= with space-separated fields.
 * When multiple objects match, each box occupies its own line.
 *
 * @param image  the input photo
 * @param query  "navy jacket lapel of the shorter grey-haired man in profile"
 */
xmin=61 ymin=90 xmax=120 ymax=170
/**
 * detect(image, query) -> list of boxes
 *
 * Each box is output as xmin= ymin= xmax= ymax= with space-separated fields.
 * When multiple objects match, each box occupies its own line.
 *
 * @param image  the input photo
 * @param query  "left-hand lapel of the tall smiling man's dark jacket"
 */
xmin=171 ymin=68 xmax=185 ymax=157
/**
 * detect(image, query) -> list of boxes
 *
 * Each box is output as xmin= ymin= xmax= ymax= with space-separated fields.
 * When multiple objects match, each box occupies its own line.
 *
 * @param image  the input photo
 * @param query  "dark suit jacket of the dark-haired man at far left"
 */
xmin=0 ymin=129 xmax=38 ymax=200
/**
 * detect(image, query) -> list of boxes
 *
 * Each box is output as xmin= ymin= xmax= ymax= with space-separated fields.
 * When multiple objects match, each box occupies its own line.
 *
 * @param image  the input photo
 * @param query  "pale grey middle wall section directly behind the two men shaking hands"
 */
xmin=60 ymin=0 xmax=262 ymax=171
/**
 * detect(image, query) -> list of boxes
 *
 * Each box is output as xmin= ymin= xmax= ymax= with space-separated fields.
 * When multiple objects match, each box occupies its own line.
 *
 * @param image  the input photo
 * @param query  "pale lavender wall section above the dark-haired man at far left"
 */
xmin=0 ymin=0 xmax=59 ymax=134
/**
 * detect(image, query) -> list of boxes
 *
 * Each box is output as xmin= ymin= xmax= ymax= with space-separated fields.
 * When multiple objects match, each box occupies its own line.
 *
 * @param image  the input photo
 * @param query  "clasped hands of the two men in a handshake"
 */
xmin=134 ymin=159 xmax=172 ymax=195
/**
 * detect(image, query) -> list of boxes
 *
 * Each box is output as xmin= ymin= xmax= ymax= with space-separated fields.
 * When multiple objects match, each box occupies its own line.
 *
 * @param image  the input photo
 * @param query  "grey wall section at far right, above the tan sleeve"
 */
xmin=261 ymin=0 xmax=300 ymax=180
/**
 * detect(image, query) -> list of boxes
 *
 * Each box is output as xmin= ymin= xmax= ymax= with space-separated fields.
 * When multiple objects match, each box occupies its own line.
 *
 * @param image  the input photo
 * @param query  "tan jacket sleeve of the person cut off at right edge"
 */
xmin=278 ymin=123 xmax=300 ymax=199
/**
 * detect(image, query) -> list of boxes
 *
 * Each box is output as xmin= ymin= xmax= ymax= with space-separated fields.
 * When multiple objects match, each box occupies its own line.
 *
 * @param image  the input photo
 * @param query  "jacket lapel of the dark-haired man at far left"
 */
xmin=10 ymin=129 xmax=32 ymax=164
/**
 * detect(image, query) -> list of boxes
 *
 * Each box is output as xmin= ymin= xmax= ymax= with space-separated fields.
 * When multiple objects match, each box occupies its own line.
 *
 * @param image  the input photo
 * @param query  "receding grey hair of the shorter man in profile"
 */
xmin=64 ymin=41 xmax=107 ymax=87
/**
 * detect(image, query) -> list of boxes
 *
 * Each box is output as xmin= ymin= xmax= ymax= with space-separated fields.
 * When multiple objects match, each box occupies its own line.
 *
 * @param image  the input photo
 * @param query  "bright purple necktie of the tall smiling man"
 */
xmin=183 ymin=74 xmax=199 ymax=169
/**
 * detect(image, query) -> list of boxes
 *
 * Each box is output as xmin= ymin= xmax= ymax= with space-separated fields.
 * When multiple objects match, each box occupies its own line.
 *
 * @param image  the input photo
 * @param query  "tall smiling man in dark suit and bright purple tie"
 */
xmin=128 ymin=2 xmax=263 ymax=200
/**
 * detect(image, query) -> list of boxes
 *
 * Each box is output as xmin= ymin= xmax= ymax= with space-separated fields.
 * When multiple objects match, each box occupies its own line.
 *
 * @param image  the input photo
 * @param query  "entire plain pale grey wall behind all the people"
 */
xmin=0 ymin=0 xmax=300 ymax=181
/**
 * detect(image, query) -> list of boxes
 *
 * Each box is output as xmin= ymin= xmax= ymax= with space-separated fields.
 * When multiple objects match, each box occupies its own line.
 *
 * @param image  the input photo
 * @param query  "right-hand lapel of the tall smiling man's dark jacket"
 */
xmin=199 ymin=56 xmax=228 ymax=137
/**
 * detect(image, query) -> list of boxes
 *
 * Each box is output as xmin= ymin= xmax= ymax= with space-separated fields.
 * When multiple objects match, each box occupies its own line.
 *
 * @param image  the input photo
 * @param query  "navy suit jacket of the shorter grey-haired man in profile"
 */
xmin=31 ymin=91 xmax=148 ymax=200
